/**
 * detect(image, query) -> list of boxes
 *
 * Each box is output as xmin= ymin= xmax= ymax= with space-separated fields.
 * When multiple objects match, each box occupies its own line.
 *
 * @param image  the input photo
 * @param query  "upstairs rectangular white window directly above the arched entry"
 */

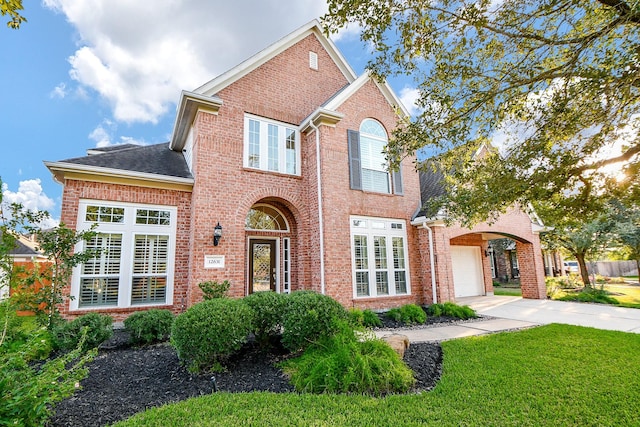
xmin=244 ymin=115 xmax=300 ymax=175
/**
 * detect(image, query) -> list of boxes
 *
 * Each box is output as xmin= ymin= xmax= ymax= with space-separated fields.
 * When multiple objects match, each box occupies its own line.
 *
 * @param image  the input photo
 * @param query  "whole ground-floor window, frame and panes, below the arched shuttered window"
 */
xmin=351 ymin=217 xmax=410 ymax=297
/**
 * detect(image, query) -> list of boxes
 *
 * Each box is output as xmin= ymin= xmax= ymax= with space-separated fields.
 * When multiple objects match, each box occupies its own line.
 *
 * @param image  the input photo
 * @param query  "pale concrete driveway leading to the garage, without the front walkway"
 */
xmin=456 ymin=296 xmax=640 ymax=334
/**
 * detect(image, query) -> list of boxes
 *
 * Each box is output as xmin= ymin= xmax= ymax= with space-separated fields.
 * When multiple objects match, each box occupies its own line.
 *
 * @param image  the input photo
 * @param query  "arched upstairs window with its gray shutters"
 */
xmin=347 ymin=119 xmax=403 ymax=195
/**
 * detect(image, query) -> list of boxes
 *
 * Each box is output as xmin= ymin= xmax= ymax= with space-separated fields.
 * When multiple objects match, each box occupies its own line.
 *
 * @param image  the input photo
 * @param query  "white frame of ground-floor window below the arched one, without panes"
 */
xmin=349 ymin=215 xmax=411 ymax=299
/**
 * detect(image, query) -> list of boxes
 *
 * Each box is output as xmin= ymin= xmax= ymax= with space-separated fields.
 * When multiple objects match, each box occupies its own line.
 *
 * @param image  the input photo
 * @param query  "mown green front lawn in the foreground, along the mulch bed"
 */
xmin=112 ymin=324 xmax=640 ymax=427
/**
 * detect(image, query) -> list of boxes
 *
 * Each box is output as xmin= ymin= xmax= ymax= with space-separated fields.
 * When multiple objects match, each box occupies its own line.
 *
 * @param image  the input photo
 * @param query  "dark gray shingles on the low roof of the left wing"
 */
xmin=61 ymin=142 xmax=193 ymax=178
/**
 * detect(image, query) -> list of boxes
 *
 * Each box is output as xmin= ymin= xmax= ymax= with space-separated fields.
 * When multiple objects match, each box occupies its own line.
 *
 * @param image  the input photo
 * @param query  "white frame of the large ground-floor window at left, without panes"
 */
xmin=70 ymin=199 xmax=178 ymax=310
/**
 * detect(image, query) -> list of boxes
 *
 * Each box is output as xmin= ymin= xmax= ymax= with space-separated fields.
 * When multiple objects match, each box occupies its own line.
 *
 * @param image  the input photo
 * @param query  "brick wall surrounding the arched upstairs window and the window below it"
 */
xmin=321 ymin=81 xmax=424 ymax=308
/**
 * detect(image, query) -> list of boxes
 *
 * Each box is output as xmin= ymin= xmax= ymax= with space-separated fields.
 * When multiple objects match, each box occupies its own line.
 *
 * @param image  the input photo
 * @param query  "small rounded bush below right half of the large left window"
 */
xmin=124 ymin=309 xmax=173 ymax=345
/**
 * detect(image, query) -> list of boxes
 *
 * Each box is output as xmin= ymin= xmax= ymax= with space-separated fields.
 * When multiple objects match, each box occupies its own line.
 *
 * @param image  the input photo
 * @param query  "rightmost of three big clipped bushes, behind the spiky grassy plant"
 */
xmin=282 ymin=291 xmax=349 ymax=351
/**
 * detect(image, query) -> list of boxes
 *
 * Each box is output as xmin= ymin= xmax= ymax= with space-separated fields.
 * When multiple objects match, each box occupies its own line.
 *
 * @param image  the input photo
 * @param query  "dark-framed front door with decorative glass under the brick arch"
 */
xmin=249 ymin=239 xmax=276 ymax=294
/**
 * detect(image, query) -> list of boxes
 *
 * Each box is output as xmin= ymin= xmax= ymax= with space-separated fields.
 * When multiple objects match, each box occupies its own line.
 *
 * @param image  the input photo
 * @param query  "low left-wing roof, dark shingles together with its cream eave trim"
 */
xmin=44 ymin=142 xmax=193 ymax=190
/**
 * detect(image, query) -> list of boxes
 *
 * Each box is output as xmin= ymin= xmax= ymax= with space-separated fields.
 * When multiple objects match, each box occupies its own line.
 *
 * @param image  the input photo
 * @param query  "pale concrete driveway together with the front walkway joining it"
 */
xmin=376 ymin=296 xmax=640 ymax=342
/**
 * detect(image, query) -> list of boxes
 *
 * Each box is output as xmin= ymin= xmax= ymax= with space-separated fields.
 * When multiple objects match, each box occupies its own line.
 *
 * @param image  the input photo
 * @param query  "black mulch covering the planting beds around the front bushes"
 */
xmin=49 ymin=318 xmax=472 ymax=427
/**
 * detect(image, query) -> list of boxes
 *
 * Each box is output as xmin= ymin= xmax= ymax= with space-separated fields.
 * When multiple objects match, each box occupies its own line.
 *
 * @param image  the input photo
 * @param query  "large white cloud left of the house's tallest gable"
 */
xmin=44 ymin=0 xmax=327 ymax=123
